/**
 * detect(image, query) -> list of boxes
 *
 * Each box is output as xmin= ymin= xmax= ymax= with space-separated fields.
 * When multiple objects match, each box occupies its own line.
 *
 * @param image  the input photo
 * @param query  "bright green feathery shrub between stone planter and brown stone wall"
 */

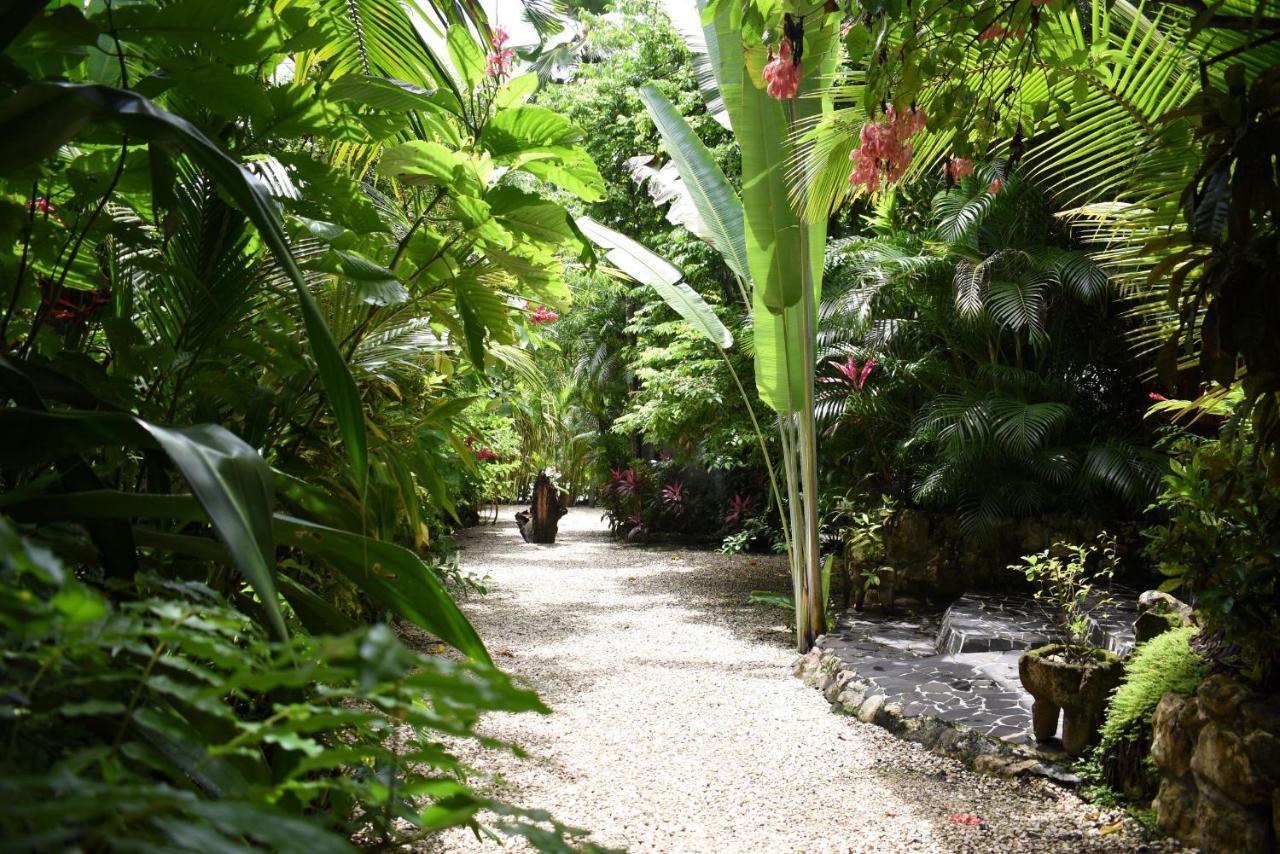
xmin=1092 ymin=626 xmax=1208 ymax=799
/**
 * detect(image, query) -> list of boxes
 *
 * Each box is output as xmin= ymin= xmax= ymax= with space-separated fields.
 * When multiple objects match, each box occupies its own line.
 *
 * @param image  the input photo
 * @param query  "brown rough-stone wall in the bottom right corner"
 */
xmin=1151 ymin=675 xmax=1280 ymax=854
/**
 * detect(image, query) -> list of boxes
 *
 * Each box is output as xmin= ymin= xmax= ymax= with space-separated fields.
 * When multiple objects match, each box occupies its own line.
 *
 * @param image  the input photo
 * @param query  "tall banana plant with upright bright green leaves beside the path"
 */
xmin=629 ymin=0 xmax=838 ymax=652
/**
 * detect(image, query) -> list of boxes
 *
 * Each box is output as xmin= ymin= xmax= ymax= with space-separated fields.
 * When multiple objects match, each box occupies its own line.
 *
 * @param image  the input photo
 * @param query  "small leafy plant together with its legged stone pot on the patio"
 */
xmin=1010 ymin=534 xmax=1124 ymax=757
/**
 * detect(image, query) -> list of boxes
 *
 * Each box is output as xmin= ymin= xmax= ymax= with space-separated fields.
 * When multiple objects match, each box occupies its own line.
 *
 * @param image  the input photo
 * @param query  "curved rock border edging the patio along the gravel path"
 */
xmin=791 ymin=647 xmax=1080 ymax=786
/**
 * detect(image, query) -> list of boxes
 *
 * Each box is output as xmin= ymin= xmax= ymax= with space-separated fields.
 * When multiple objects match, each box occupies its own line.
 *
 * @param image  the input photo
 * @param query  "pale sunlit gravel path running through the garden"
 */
xmin=419 ymin=507 xmax=1140 ymax=854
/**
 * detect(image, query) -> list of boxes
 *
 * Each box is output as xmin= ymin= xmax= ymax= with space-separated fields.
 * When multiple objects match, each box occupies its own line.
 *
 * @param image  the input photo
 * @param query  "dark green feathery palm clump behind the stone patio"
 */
xmin=818 ymin=172 xmax=1160 ymax=534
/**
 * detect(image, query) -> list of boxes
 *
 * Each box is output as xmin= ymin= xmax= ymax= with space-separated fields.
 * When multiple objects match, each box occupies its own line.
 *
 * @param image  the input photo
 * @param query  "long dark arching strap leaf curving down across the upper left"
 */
xmin=0 ymin=82 xmax=369 ymax=494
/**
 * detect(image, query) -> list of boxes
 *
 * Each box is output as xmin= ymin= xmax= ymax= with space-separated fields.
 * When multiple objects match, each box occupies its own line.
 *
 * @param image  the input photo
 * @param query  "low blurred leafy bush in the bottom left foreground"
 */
xmin=0 ymin=517 xmax=604 ymax=854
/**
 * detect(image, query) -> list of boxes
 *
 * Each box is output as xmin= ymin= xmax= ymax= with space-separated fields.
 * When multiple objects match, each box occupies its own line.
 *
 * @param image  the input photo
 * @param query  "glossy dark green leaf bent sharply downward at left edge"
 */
xmin=0 ymin=408 xmax=288 ymax=638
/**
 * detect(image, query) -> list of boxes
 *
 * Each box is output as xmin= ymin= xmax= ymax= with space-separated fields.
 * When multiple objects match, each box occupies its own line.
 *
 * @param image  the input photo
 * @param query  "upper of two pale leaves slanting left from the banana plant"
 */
xmin=640 ymin=83 xmax=751 ymax=282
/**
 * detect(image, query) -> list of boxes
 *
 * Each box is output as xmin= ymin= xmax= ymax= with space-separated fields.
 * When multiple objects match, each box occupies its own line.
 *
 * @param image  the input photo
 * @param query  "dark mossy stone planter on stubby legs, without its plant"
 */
xmin=1018 ymin=644 xmax=1124 ymax=757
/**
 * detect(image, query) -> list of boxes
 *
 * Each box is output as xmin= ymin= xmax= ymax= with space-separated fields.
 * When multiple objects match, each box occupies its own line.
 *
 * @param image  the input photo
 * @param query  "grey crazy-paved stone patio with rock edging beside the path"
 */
xmin=797 ymin=592 xmax=1137 ymax=778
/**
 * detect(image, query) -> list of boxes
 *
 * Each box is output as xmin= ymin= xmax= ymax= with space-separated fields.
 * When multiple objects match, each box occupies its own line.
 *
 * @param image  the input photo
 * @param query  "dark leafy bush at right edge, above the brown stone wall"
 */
xmin=1144 ymin=419 xmax=1280 ymax=684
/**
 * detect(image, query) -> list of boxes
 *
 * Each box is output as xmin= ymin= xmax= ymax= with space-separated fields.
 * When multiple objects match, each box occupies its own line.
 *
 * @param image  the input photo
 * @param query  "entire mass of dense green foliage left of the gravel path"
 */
xmin=0 ymin=0 xmax=603 ymax=850
